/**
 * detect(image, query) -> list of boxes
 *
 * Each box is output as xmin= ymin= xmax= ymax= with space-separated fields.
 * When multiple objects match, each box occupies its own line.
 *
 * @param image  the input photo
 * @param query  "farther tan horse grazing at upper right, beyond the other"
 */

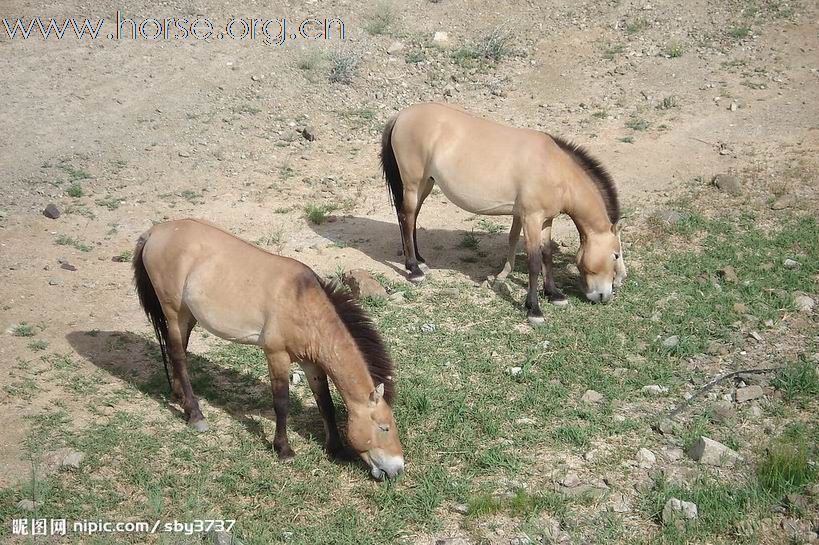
xmin=381 ymin=104 xmax=626 ymax=324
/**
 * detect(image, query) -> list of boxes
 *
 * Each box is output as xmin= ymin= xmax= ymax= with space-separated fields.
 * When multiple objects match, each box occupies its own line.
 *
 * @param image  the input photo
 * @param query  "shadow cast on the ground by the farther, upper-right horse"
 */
xmin=310 ymin=216 xmax=585 ymax=304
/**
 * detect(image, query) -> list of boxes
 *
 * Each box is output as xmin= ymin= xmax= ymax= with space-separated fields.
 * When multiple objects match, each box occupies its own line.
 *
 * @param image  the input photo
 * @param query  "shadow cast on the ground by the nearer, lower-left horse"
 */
xmin=66 ymin=330 xmax=363 ymax=468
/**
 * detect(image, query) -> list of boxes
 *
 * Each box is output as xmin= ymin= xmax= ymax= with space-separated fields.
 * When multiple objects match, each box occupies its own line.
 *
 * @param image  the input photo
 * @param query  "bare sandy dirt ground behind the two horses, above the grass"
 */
xmin=0 ymin=0 xmax=819 ymax=536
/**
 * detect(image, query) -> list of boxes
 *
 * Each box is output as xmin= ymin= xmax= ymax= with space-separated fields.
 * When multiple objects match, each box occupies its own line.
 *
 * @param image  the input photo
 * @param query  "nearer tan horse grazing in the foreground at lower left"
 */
xmin=134 ymin=219 xmax=404 ymax=479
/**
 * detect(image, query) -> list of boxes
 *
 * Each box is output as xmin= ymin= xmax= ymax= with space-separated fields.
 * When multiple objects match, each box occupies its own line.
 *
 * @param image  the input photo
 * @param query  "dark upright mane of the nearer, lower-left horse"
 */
xmin=319 ymin=278 xmax=395 ymax=406
